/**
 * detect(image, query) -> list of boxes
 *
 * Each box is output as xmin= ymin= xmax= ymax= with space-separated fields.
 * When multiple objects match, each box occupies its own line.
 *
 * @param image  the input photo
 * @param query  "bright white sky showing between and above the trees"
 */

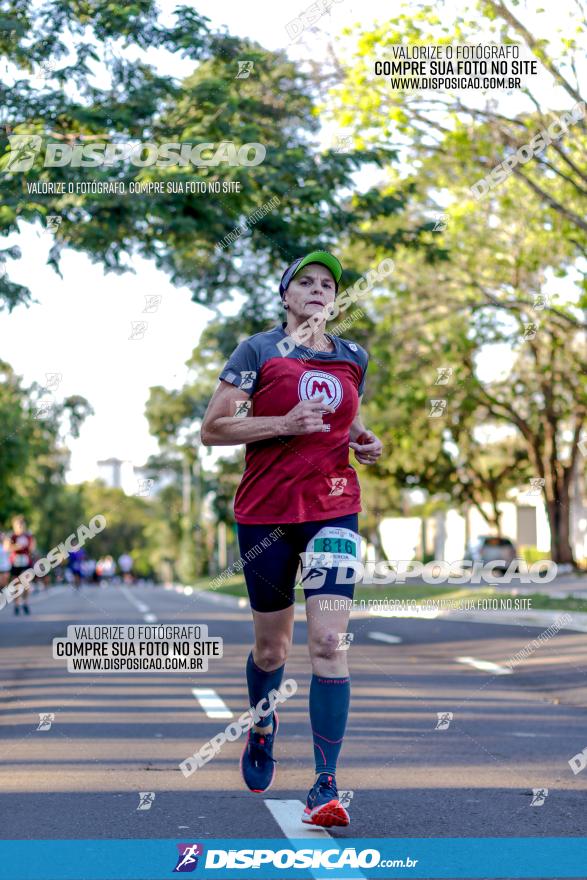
xmin=0 ymin=0 xmax=572 ymax=482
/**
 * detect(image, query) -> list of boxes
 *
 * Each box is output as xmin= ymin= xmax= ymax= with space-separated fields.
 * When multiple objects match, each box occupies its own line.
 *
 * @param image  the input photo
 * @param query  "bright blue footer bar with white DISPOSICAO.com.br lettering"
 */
xmin=0 ymin=837 xmax=587 ymax=880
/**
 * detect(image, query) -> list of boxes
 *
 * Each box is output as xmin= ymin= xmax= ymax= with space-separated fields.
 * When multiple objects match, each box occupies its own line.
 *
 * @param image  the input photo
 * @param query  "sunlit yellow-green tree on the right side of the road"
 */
xmin=329 ymin=0 xmax=587 ymax=563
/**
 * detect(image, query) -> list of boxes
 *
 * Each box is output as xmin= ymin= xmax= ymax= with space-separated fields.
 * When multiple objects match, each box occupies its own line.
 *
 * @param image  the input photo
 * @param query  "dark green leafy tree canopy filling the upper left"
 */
xmin=0 ymin=0 xmax=402 ymax=313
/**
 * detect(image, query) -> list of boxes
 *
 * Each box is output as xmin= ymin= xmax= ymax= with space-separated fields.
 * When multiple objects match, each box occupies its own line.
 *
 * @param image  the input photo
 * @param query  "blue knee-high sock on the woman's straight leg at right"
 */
xmin=310 ymin=675 xmax=351 ymax=776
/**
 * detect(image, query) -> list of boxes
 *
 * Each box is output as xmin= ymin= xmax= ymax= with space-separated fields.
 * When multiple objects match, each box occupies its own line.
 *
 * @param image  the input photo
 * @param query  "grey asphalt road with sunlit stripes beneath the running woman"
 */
xmin=0 ymin=586 xmax=587 ymax=840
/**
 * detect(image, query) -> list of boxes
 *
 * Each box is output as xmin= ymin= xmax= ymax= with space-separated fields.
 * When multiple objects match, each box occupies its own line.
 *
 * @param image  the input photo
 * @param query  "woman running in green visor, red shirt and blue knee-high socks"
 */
xmin=201 ymin=251 xmax=382 ymax=826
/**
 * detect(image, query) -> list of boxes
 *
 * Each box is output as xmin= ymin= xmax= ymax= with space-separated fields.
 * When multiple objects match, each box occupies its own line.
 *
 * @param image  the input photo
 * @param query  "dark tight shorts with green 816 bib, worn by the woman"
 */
xmin=237 ymin=513 xmax=361 ymax=611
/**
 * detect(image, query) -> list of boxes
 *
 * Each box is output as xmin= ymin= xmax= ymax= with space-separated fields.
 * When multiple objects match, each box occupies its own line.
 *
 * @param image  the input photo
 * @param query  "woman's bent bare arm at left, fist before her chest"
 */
xmin=200 ymin=380 xmax=334 ymax=446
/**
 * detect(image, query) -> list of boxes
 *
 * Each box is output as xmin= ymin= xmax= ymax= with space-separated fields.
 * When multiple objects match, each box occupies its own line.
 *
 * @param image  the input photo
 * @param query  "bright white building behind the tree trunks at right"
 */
xmin=379 ymin=467 xmax=587 ymax=563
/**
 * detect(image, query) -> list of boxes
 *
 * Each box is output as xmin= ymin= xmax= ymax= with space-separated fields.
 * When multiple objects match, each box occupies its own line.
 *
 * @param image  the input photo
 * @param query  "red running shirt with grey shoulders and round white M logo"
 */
xmin=220 ymin=324 xmax=369 ymax=525
